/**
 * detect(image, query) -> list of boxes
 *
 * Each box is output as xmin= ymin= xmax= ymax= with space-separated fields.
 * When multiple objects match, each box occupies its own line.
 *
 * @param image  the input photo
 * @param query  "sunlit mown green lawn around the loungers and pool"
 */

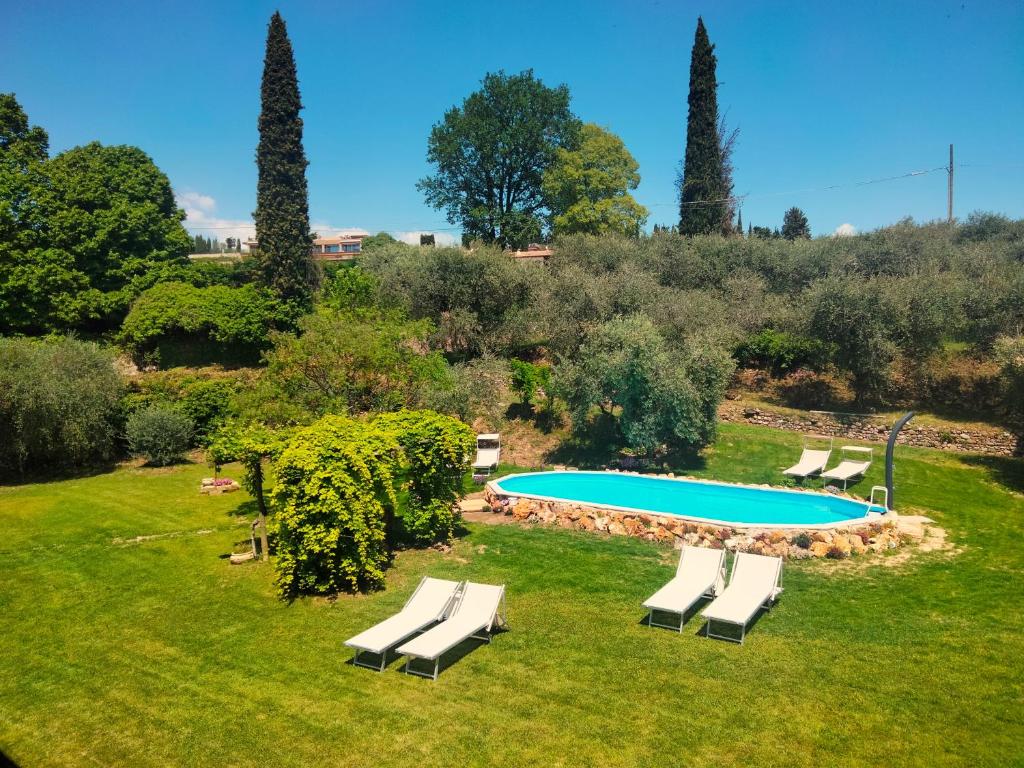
xmin=0 ymin=425 xmax=1024 ymax=768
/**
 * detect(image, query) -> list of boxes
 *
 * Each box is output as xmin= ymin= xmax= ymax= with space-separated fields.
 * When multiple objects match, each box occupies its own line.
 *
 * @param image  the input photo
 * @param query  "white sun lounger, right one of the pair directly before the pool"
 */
xmin=701 ymin=552 xmax=782 ymax=643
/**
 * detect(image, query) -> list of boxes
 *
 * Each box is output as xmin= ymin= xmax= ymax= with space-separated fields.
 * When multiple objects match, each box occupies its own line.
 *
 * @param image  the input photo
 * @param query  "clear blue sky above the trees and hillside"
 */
xmin=0 ymin=0 xmax=1024 ymax=243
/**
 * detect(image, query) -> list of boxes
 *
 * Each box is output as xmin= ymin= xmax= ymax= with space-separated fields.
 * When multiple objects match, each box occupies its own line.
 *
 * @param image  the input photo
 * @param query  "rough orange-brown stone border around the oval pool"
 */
xmin=483 ymin=472 xmax=910 ymax=559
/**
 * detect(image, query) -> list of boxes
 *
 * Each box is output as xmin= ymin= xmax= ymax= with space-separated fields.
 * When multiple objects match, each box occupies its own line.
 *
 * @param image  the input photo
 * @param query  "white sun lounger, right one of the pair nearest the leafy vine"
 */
xmin=396 ymin=582 xmax=505 ymax=680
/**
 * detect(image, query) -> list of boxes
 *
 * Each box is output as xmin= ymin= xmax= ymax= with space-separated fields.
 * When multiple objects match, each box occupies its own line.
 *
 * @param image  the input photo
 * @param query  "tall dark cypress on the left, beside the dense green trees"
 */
xmin=253 ymin=11 xmax=316 ymax=306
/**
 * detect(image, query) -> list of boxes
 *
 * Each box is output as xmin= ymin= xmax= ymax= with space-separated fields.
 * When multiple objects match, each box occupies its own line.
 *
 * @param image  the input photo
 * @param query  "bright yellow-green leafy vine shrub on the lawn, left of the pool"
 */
xmin=264 ymin=411 xmax=473 ymax=597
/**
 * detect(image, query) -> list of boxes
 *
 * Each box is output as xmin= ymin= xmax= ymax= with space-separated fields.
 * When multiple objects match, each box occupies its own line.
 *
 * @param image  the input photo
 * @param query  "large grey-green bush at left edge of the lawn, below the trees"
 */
xmin=0 ymin=338 xmax=124 ymax=473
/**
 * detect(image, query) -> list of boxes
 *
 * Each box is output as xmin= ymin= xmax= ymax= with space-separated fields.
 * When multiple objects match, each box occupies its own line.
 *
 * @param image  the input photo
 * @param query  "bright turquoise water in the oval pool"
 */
xmin=495 ymin=472 xmax=883 ymax=526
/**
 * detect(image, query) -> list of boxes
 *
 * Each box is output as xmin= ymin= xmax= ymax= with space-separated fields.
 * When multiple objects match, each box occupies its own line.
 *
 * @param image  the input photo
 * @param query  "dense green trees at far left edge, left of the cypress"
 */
xmin=0 ymin=94 xmax=190 ymax=333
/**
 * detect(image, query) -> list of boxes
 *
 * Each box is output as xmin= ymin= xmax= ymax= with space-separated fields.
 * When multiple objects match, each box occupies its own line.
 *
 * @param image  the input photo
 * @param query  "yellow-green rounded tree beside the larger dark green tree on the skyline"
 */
xmin=544 ymin=123 xmax=647 ymax=238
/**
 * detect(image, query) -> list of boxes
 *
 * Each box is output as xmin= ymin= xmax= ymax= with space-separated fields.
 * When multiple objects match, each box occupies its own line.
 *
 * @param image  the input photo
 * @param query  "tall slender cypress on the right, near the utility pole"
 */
xmin=679 ymin=16 xmax=728 ymax=234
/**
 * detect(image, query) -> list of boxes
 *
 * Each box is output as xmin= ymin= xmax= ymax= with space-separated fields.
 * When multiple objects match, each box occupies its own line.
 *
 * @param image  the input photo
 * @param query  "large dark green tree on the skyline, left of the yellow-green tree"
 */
xmin=417 ymin=70 xmax=580 ymax=248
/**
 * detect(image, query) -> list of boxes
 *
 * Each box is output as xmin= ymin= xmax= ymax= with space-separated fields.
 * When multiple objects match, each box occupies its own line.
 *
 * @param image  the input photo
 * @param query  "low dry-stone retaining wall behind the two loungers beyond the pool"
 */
xmin=718 ymin=400 xmax=1017 ymax=456
